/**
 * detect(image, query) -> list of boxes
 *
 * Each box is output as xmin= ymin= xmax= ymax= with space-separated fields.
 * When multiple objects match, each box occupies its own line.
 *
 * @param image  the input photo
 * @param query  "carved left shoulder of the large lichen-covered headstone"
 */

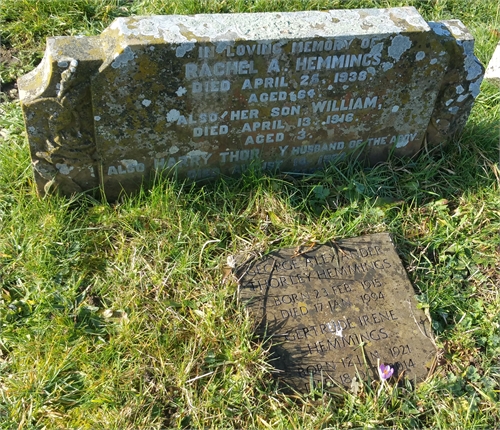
xmin=18 ymin=37 xmax=102 ymax=196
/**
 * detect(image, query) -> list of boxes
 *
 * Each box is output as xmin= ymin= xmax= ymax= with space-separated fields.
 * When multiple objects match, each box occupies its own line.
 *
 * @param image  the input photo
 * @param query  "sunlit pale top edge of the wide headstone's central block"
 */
xmin=102 ymin=7 xmax=430 ymax=43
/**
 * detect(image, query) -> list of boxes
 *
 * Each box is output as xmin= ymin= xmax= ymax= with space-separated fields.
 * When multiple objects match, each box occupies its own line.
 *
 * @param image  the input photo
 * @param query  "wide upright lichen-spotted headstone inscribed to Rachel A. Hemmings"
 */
xmin=18 ymin=7 xmax=484 ymax=200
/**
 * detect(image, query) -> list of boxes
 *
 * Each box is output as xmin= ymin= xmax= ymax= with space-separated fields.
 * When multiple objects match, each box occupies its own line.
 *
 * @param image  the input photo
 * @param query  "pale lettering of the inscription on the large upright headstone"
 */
xmin=154 ymin=30 xmax=426 ymax=178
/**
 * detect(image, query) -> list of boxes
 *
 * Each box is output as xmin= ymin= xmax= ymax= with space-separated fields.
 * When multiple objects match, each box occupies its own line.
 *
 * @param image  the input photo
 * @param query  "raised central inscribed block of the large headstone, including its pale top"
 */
xmin=84 ymin=8 xmax=478 ymax=199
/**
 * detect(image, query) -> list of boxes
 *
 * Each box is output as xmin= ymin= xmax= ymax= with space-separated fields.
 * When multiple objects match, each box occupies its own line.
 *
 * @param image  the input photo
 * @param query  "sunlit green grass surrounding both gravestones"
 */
xmin=0 ymin=0 xmax=500 ymax=430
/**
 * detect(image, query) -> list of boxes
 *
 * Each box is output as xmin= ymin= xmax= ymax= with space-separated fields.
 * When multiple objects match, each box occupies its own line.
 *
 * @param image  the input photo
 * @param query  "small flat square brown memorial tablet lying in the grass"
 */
xmin=236 ymin=233 xmax=436 ymax=392
